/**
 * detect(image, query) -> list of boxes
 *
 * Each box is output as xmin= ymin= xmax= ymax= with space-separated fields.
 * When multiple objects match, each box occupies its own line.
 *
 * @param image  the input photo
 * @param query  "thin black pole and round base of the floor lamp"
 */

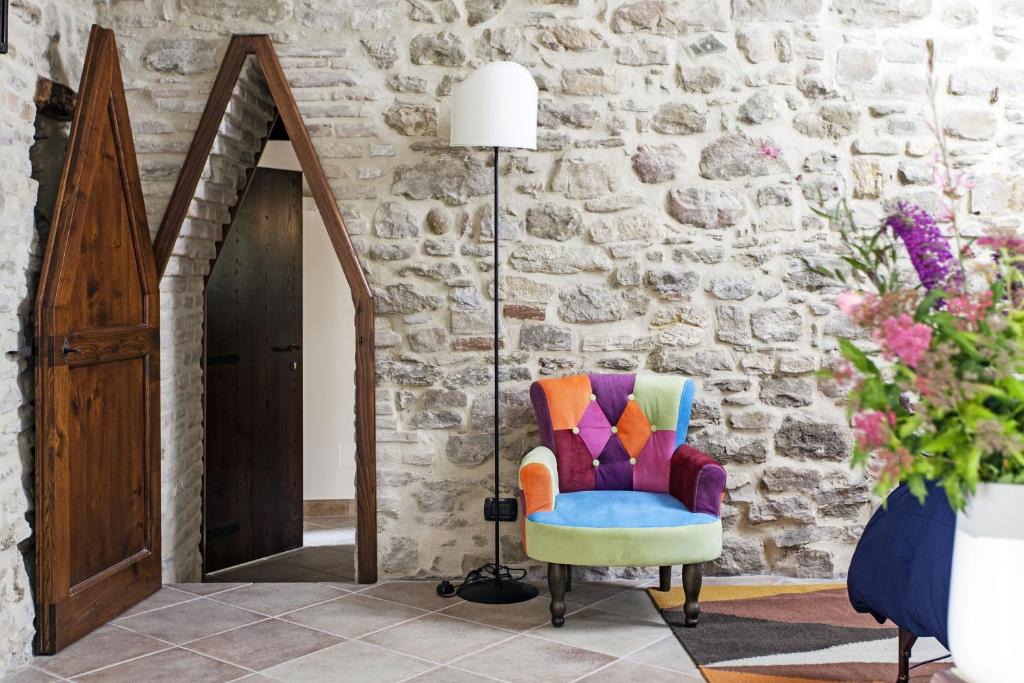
xmin=437 ymin=147 xmax=539 ymax=604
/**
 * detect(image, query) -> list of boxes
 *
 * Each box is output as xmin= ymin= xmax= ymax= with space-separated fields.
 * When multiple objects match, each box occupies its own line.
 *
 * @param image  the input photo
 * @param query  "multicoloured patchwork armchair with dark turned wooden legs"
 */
xmin=519 ymin=375 xmax=725 ymax=627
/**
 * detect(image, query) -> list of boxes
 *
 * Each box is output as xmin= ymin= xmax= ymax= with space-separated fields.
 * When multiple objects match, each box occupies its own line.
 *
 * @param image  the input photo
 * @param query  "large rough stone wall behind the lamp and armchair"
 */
xmin=101 ymin=0 xmax=1024 ymax=577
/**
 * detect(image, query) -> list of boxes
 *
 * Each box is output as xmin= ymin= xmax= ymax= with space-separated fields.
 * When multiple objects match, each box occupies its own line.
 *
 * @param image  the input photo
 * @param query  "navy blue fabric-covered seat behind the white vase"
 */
xmin=847 ymin=483 xmax=956 ymax=648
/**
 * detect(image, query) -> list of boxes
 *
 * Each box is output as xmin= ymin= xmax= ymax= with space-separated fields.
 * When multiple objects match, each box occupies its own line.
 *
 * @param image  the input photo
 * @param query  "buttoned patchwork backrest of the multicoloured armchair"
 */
xmin=529 ymin=375 xmax=696 ymax=493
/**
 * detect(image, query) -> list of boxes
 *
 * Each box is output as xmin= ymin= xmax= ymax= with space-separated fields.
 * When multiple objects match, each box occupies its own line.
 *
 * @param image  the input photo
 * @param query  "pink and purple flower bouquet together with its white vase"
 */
xmin=811 ymin=43 xmax=1024 ymax=683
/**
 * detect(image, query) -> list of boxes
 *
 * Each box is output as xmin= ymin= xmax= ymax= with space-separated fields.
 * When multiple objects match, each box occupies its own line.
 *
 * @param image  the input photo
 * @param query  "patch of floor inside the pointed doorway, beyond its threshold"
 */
xmin=207 ymin=516 xmax=355 ymax=584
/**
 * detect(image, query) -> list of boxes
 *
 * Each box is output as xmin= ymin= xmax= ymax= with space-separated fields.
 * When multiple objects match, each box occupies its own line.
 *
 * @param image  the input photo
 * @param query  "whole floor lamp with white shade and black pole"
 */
xmin=437 ymin=61 xmax=538 ymax=604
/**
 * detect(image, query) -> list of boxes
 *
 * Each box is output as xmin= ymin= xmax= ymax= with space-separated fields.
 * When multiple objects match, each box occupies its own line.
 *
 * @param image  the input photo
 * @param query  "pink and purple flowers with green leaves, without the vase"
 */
xmin=811 ymin=44 xmax=1024 ymax=510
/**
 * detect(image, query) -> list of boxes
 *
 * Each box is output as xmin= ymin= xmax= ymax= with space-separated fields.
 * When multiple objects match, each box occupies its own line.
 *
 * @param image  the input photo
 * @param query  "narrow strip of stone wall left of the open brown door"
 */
xmin=0 ymin=0 xmax=93 ymax=679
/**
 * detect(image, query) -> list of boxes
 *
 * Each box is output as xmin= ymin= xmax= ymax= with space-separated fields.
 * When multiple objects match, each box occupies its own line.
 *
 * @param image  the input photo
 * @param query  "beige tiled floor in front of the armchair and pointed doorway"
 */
xmin=16 ymin=578 xmax=708 ymax=683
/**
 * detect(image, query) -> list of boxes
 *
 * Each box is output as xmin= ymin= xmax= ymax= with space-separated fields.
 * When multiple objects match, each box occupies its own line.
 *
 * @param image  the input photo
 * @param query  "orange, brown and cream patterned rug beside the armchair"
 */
xmin=648 ymin=583 xmax=950 ymax=683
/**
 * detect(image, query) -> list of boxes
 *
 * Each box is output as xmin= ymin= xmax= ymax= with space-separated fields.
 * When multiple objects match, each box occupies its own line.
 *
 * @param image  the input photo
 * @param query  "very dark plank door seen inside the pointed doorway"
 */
xmin=204 ymin=168 xmax=302 ymax=572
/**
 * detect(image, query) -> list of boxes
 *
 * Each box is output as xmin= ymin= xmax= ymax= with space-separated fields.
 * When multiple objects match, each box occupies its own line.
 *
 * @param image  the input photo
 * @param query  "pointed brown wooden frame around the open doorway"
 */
xmin=154 ymin=35 xmax=377 ymax=584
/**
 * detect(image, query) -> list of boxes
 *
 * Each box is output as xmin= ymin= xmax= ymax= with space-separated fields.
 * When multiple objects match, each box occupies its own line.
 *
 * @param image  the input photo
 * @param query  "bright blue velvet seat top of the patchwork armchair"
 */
xmin=529 ymin=490 xmax=718 ymax=528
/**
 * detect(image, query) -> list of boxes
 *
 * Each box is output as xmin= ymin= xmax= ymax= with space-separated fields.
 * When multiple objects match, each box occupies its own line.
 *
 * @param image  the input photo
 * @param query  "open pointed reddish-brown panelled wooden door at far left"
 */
xmin=35 ymin=27 xmax=160 ymax=653
